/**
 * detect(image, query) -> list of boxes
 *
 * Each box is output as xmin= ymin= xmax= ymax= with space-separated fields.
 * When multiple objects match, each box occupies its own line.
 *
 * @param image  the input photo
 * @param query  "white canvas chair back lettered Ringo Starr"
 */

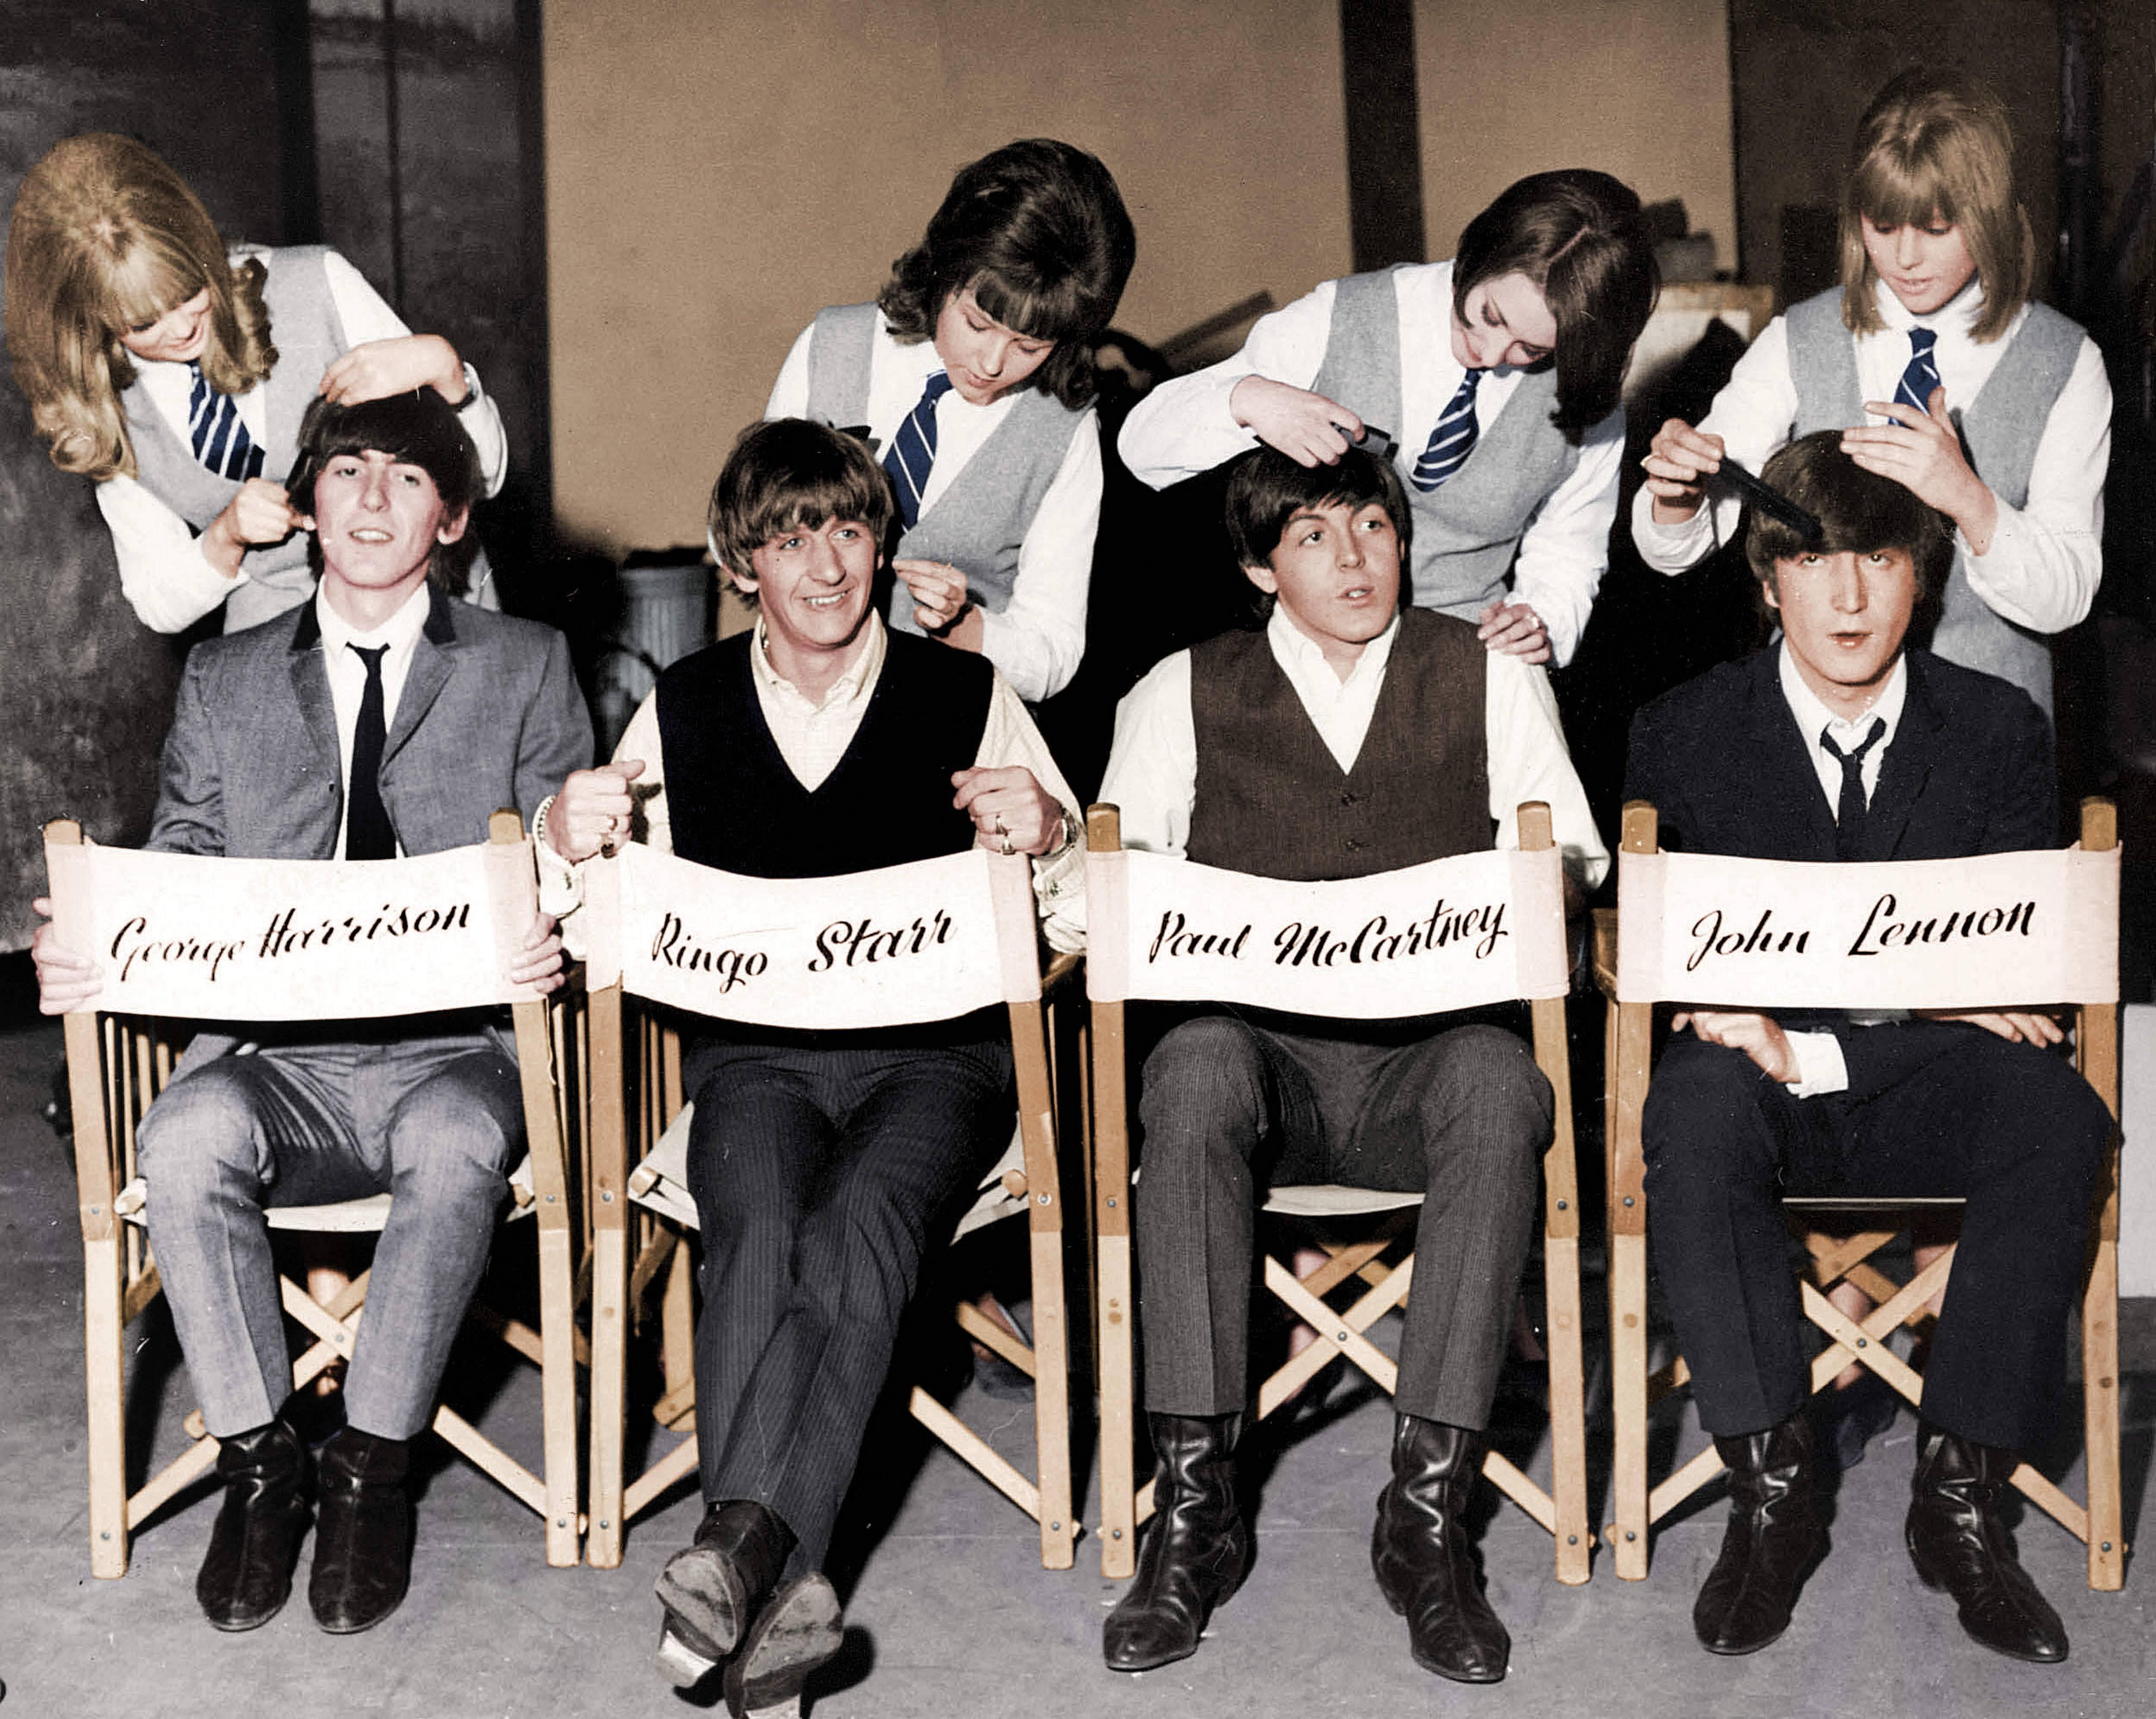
xmin=586 ymin=847 xmax=1039 ymax=1027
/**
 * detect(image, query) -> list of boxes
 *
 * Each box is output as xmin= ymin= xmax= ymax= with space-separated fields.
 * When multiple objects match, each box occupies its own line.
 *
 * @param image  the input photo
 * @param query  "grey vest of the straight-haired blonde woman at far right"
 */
xmin=1787 ymin=287 xmax=2083 ymax=716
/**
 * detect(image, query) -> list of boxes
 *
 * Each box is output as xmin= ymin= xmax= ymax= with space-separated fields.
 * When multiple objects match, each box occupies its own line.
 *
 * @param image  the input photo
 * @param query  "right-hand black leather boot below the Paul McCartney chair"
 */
xmin=1369 ymin=1415 xmax=1511 ymax=1682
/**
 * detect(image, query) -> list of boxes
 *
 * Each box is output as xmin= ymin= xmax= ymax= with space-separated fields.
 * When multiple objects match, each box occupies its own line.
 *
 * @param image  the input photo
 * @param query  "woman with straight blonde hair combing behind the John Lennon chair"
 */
xmin=1632 ymin=69 xmax=2111 ymax=716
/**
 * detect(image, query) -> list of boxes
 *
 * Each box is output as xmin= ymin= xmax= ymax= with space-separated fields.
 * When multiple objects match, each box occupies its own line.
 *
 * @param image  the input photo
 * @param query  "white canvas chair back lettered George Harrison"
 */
xmin=45 ymin=843 xmax=535 ymax=1020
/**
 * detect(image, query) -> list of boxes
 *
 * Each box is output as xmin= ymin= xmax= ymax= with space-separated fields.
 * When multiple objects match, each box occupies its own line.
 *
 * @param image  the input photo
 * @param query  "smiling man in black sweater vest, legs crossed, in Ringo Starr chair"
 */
xmin=543 ymin=418 xmax=1084 ymax=1715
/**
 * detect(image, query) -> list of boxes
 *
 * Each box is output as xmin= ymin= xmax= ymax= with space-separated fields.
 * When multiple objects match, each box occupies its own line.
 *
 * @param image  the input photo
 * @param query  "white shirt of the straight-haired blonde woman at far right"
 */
xmin=1632 ymin=280 xmax=2111 ymax=632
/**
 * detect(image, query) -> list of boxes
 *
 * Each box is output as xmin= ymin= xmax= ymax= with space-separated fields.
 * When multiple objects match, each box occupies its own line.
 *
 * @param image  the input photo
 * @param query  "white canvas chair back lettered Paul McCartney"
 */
xmin=1087 ymin=850 xmax=1565 ymax=1020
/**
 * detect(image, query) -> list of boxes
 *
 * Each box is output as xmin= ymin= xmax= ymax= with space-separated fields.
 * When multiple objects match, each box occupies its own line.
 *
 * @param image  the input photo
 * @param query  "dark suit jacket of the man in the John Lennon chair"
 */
xmin=1626 ymin=645 xmax=2059 ymax=1094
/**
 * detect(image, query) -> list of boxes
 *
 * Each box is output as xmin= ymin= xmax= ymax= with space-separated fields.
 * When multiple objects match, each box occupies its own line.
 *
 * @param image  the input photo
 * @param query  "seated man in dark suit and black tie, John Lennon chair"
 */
xmin=1626 ymin=431 xmax=2111 ymax=1661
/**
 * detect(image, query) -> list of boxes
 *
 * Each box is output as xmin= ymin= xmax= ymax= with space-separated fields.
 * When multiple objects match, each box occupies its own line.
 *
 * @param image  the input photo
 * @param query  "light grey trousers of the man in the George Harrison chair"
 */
xmin=138 ymin=1031 xmax=524 ymax=1439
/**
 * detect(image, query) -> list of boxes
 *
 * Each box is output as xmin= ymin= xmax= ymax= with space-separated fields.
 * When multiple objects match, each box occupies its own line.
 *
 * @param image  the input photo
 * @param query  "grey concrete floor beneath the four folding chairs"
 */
xmin=0 ymin=1027 xmax=2156 ymax=1719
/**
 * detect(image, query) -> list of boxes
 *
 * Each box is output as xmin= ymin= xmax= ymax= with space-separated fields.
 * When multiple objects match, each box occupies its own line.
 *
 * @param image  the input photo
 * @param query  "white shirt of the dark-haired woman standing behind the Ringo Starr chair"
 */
xmin=763 ymin=310 xmax=1102 ymax=703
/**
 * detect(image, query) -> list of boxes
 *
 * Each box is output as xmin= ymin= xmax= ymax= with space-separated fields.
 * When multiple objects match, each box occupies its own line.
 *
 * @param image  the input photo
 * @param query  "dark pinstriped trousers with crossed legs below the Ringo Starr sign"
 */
xmin=686 ymin=1035 xmax=1011 ymax=1575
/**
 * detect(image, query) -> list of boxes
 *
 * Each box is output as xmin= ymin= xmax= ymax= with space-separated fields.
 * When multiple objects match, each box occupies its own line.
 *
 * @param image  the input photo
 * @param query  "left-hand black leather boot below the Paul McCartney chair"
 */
xmin=1102 ymin=1415 xmax=1250 ymax=1672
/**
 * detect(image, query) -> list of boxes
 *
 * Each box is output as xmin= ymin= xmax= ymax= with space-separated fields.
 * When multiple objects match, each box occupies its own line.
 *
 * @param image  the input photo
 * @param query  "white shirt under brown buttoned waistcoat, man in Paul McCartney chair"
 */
xmin=1100 ymin=604 xmax=1611 ymax=889
